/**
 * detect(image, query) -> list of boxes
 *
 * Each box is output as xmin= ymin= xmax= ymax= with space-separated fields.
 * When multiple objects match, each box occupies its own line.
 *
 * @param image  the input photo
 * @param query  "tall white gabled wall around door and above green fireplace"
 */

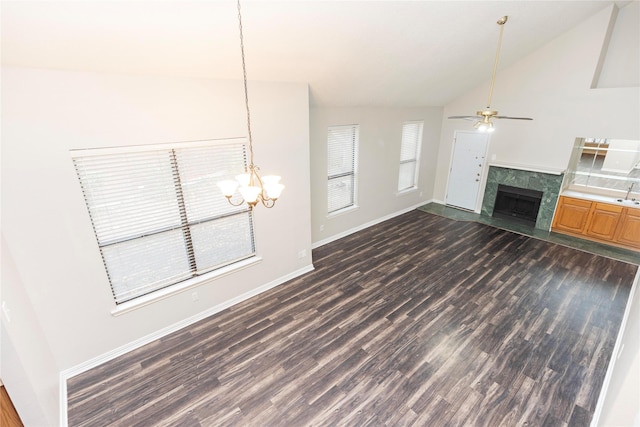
xmin=434 ymin=5 xmax=640 ymax=200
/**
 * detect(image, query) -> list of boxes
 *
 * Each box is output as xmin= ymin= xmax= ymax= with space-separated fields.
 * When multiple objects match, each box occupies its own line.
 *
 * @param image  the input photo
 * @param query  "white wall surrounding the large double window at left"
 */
xmin=2 ymin=68 xmax=311 ymax=424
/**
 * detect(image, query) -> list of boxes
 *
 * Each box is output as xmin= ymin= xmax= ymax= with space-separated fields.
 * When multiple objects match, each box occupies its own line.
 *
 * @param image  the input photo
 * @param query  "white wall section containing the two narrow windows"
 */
xmin=310 ymin=107 xmax=442 ymax=244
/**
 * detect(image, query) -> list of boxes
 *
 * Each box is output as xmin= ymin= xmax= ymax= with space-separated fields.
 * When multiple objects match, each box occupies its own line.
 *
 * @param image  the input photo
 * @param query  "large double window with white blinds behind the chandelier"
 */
xmin=73 ymin=139 xmax=255 ymax=304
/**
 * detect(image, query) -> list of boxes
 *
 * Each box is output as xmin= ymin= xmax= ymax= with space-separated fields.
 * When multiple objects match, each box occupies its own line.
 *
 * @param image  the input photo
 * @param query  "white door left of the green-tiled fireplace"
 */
xmin=445 ymin=132 xmax=489 ymax=211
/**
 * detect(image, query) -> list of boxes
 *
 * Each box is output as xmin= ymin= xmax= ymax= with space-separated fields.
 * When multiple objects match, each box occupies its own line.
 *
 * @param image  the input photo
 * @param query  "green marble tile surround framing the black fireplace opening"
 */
xmin=481 ymin=165 xmax=563 ymax=231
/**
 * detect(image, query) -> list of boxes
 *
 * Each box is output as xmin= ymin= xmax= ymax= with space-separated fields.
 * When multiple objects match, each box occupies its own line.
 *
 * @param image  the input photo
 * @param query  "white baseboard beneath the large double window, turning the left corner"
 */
xmin=60 ymin=264 xmax=314 ymax=427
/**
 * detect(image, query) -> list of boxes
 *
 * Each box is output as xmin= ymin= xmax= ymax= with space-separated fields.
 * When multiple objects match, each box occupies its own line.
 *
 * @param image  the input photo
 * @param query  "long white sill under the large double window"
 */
xmin=111 ymin=256 xmax=262 ymax=316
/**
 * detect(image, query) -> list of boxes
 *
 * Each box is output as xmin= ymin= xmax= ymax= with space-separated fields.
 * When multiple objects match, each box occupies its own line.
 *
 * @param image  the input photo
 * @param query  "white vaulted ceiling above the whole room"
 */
xmin=1 ymin=0 xmax=628 ymax=106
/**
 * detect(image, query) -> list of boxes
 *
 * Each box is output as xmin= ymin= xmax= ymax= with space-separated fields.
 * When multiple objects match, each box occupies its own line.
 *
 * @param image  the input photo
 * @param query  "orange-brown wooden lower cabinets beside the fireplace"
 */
xmin=551 ymin=196 xmax=640 ymax=250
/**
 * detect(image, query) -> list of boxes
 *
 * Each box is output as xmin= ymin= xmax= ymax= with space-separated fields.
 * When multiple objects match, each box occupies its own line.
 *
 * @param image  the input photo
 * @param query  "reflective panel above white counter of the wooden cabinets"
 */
xmin=565 ymin=138 xmax=640 ymax=196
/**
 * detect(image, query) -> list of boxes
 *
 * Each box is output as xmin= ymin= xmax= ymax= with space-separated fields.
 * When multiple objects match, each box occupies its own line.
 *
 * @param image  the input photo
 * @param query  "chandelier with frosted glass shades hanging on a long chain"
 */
xmin=218 ymin=0 xmax=284 ymax=209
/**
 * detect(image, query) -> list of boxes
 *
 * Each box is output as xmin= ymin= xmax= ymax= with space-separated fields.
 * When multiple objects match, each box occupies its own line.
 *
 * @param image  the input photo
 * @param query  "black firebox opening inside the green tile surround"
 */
xmin=493 ymin=184 xmax=542 ymax=226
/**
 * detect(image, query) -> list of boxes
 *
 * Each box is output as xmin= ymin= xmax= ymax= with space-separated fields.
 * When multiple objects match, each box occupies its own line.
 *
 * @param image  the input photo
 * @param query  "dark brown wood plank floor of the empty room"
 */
xmin=68 ymin=211 xmax=637 ymax=426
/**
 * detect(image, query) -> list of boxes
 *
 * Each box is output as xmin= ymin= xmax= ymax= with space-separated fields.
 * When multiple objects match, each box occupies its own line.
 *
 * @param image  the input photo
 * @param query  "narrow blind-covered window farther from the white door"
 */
xmin=327 ymin=125 xmax=359 ymax=213
